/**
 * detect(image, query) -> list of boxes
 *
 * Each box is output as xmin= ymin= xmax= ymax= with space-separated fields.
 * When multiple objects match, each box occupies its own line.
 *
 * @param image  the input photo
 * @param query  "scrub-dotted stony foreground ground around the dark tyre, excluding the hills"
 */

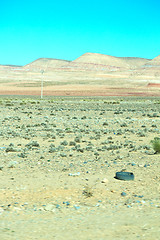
xmin=0 ymin=96 xmax=160 ymax=240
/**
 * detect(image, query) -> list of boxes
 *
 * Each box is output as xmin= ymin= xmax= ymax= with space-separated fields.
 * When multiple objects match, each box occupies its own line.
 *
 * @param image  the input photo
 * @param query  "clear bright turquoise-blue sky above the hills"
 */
xmin=0 ymin=0 xmax=160 ymax=65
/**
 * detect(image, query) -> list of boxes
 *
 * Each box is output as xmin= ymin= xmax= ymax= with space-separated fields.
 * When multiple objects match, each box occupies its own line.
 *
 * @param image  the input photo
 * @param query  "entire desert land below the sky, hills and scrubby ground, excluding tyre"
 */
xmin=0 ymin=54 xmax=160 ymax=240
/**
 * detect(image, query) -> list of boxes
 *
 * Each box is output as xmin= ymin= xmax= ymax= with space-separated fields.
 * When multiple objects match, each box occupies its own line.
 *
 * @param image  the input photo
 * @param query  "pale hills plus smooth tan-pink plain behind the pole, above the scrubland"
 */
xmin=0 ymin=53 xmax=160 ymax=95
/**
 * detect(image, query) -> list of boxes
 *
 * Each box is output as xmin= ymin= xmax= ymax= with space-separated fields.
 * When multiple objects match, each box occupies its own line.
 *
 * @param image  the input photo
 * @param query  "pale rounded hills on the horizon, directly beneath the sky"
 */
xmin=0 ymin=52 xmax=156 ymax=70
